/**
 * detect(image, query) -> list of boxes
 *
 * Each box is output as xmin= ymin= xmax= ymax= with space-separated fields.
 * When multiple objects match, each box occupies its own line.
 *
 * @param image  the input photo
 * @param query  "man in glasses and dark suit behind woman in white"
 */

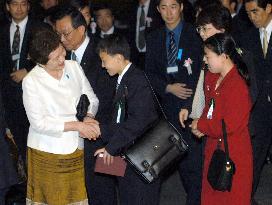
xmin=54 ymin=6 xmax=116 ymax=205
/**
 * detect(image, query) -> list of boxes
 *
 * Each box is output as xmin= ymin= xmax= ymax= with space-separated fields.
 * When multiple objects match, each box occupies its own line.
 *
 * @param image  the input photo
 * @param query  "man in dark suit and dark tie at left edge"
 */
xmin=1 ymin=0 xmax=38 ymax=165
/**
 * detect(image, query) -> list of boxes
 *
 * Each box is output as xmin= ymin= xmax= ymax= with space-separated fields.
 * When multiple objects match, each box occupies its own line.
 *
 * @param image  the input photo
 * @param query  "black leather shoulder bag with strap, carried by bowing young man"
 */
xmin=123 ymin=75 xmax=188 ymax=183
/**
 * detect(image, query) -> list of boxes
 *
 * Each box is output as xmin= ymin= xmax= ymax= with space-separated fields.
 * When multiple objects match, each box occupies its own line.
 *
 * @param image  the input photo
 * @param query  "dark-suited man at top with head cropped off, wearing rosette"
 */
xmin=129 ymin=0 xmax=163 ymax=69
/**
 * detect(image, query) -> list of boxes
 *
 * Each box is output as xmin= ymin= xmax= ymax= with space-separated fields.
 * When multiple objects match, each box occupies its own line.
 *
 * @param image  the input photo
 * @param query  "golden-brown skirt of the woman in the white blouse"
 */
xmin=26 ymin=148 xmax=88 ymax=205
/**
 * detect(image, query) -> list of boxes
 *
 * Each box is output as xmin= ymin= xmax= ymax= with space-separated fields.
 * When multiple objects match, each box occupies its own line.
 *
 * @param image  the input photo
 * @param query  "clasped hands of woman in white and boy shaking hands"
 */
xmin=79 ymin=117 xmax=101 ymax=140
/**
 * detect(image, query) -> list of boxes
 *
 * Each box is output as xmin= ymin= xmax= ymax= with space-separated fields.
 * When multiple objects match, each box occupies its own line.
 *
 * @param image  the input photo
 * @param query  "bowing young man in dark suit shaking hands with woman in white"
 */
xmin=95 ymin=34 xmax=160 ymax=205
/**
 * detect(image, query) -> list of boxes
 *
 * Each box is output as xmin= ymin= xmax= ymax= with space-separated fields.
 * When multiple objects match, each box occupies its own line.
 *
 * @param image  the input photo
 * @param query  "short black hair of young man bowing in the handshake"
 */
xmin=96 ymin=34 xmax=130 ymax=60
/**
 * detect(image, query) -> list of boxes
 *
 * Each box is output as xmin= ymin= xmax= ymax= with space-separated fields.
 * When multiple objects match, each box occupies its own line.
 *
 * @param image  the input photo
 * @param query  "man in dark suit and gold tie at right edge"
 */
xmin=239 ymin=0 xmax=272 ymax=203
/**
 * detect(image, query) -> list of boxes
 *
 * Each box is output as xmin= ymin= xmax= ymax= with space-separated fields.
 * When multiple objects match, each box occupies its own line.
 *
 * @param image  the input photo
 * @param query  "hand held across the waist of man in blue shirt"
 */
xmin=166 ymin=83 xmax=193 ymax=100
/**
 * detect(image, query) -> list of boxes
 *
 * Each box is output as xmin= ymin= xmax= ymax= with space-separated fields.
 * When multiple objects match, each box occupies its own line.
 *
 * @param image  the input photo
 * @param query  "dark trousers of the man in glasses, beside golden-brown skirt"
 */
xmin=84 ymin=140 xmax=117 ymax=205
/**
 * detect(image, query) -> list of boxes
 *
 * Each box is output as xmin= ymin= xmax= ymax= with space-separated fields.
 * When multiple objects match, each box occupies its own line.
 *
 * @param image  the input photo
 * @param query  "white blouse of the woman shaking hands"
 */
xmin=23 ymin=61 xmax=99 ymax=154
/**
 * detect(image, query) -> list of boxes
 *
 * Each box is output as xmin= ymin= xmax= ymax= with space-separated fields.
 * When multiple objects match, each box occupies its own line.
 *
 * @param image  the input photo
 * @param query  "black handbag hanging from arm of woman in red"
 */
xmin=207 ymin=120 xmax=235 ymax=192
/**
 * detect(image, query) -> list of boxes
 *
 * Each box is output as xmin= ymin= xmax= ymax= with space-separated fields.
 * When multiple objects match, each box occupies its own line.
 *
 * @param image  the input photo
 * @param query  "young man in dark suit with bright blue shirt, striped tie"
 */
xmin=145 ymin=0 xmax=203 ymax=205
